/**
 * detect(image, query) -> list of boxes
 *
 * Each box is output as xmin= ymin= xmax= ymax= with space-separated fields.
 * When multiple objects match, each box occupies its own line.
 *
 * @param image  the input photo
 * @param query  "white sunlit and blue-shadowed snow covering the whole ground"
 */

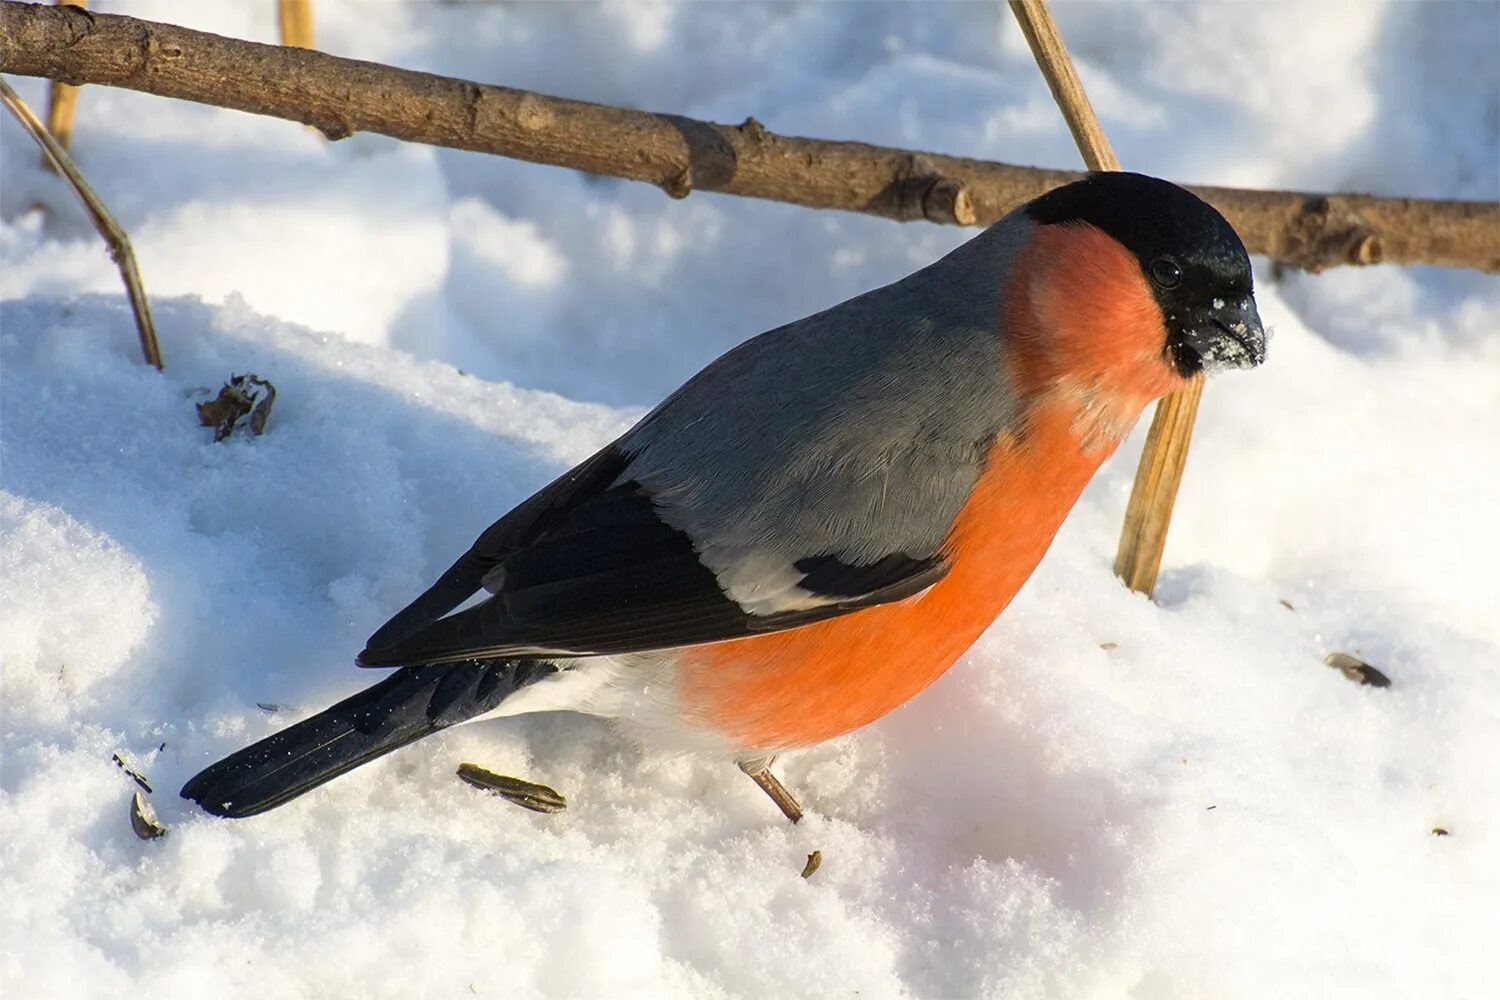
xmin=0 ymin=0 xmax=1500 ymax=999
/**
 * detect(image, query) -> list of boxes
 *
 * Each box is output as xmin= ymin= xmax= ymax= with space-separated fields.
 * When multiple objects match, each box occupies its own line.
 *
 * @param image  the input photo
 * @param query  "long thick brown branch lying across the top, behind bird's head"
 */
xmin=0 ymin=0 xmax=1500 ymax=271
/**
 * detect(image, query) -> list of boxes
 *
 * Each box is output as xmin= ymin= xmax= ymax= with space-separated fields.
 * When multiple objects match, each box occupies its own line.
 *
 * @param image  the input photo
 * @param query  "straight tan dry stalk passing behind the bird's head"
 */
xmin=1011 ymin=0 xmax=1203 ymax=597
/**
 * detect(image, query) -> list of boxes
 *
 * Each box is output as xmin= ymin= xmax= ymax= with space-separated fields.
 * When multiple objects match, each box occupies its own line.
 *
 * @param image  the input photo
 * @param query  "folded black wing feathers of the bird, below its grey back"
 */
xmin=359 ymin=447 xmax=948 ymax=667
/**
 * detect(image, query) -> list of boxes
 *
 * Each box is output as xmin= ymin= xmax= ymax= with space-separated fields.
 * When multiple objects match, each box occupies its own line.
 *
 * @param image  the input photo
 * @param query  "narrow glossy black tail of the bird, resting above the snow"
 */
xmin=182 ymin=660 xmax=557 ymax=819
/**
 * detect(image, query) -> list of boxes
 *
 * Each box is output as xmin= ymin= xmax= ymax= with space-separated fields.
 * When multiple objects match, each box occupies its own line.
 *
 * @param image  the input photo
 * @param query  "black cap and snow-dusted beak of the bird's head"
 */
xmin=1025 ymin=171 xmax=1266 ymax=376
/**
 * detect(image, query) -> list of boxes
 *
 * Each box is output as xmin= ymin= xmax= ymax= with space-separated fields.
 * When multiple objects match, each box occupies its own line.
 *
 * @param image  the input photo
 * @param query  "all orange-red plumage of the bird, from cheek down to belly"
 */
xmin=678 ymin=225 xmax=1181 ymax=750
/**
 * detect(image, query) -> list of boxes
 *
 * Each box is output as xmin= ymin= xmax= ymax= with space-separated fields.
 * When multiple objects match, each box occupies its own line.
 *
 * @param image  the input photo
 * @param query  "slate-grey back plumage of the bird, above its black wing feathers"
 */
xmin=617 ymin=213 xmax=1034 ymax=610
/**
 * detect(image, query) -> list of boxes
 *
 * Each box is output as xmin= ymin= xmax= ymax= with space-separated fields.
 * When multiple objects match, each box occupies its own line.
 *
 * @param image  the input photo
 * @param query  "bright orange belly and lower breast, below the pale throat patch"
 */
xmin=678 ymin=406 xmax=1139 ymax=750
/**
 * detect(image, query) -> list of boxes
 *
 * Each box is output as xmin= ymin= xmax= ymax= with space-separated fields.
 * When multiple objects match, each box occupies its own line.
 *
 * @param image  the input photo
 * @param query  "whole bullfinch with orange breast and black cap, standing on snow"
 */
xmin=182 ymin=172 xmax=1266 ymax=822
